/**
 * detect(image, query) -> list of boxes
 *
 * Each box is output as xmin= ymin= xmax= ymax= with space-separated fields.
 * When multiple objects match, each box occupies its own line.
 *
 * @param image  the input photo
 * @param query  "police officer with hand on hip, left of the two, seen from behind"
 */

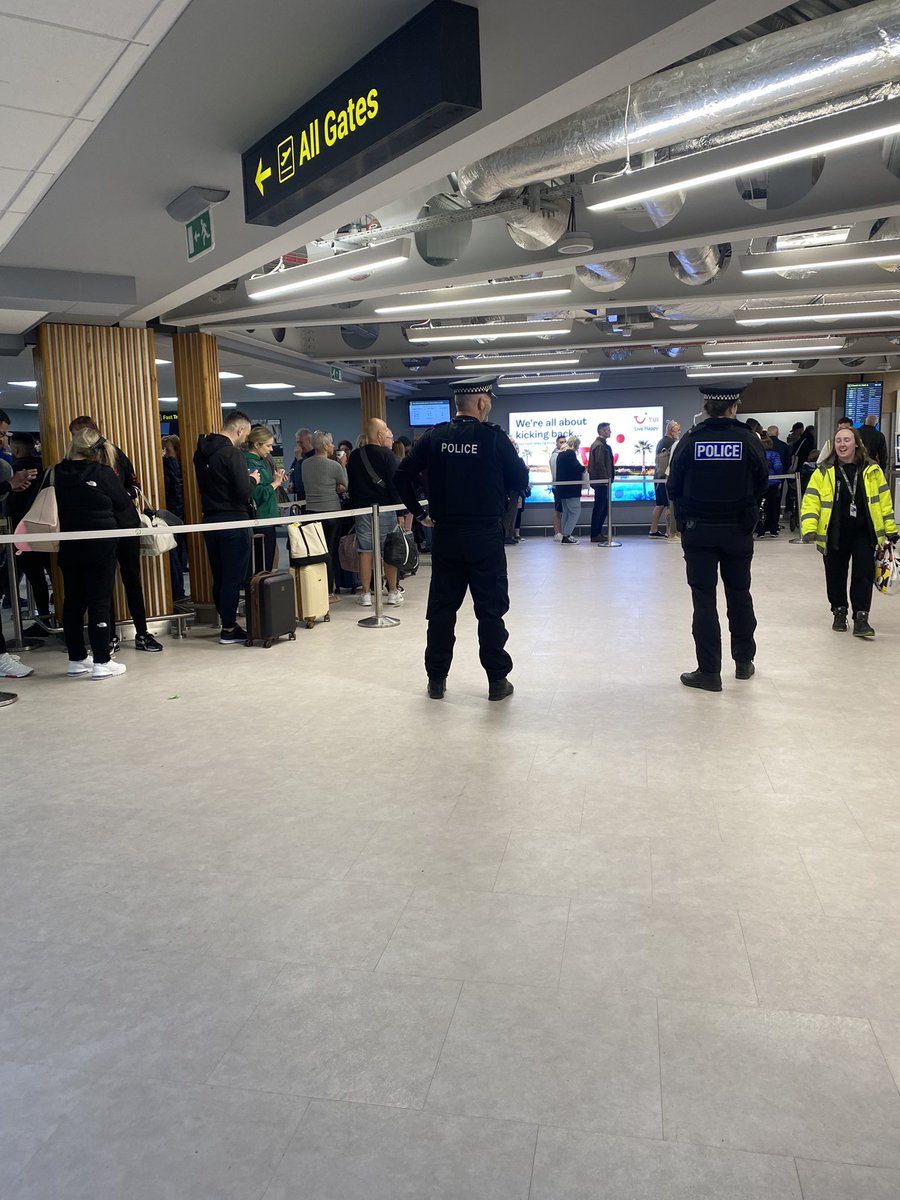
xmin=395 ymin=379 xmax=528 ymax=700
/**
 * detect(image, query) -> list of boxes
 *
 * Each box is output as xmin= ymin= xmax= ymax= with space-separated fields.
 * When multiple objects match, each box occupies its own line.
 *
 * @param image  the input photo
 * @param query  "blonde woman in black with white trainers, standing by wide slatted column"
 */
xmin=53 ymin=425 xmax=138 ymax=679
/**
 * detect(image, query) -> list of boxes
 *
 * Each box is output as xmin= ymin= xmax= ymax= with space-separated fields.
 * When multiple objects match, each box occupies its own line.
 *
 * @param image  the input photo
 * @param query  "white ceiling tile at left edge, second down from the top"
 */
xmin=0 ymin=16 xmax=122 ymax=116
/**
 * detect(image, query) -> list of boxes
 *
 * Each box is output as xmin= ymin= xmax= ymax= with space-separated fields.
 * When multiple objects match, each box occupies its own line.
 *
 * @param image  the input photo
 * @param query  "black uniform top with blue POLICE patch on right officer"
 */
xmin=676 ymin=419 xmax=760 ymax=522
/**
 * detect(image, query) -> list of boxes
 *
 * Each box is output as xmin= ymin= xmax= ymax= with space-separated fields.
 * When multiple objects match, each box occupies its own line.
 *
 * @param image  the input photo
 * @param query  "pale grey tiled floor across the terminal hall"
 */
xmin=0 ymin=536 xmax=900 ymax=1200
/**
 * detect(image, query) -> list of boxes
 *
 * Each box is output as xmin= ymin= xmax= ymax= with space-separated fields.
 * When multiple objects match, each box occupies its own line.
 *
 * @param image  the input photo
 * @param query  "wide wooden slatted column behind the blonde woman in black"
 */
xmin=34 ymin=325 xmax=172 ymax=619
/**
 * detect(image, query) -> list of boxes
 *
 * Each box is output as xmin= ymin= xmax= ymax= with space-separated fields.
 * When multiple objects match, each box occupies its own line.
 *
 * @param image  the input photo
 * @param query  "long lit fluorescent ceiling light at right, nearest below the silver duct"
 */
xmin=583 ymin=122 xmax=900 ymax=212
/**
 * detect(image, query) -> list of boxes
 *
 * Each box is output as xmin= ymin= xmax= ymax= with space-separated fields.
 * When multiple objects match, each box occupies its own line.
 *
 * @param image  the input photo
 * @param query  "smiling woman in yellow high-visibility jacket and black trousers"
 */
xmin=800 ymin=426 xmax=898 ymax=638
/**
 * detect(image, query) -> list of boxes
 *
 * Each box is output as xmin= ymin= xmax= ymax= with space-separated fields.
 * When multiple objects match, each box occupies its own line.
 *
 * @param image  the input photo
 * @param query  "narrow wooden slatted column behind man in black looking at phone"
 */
xmin=172 ymin=334 xmax=222 ymax=604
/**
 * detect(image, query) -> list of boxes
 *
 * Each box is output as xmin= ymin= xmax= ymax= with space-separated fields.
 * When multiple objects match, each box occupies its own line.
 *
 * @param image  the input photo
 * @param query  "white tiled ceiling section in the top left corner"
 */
xmin=0 ymin=0 xmax=190 ymax=253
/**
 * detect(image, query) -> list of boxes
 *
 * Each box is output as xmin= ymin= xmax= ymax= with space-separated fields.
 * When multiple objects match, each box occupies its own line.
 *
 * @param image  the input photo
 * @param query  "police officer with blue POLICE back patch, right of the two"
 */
xmin=666 ymin=388 xmax=769 ymax=691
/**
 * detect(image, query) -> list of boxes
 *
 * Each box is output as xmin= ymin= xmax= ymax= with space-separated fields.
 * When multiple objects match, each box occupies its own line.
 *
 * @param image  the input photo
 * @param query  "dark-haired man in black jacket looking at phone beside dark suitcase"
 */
xmin=193 ymin=408 xmax=259 ymax=646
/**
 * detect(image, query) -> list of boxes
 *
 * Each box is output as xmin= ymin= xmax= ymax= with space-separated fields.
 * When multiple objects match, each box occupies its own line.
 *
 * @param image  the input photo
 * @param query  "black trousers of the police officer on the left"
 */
xmin=425 ymin=520 xmax=512 ymax=679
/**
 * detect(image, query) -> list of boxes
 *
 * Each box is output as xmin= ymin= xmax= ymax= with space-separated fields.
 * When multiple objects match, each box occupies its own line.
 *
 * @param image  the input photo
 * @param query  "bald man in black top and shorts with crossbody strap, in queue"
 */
xmin=347 ymin=416 xmax=403 ymax=608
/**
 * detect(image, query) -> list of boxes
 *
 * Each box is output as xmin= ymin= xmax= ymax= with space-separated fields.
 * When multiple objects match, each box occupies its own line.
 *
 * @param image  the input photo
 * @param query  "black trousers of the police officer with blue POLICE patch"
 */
xmin=682 ymin=521 xmax=756 ymax=674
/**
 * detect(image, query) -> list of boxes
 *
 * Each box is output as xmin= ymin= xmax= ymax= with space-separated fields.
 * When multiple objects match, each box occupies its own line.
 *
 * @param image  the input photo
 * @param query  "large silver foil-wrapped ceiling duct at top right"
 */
xmin=458 ymin=0 xmax=900 ymax=204
